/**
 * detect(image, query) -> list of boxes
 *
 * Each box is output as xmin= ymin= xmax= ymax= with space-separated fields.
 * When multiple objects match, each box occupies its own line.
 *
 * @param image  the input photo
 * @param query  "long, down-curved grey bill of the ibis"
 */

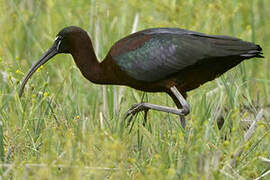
xmin=19 ymin=44 xmax=58 ymax=97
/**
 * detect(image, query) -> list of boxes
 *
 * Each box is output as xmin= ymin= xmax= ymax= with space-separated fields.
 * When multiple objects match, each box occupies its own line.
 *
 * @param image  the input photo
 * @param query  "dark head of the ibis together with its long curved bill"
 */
xmin=19 ymin=26 xmax=88 ymax=97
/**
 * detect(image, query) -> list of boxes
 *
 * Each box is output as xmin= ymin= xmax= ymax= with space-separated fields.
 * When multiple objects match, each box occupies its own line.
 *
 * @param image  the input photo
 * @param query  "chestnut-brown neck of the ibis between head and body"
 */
xmin=71 ymin=42 xmax=109 ymax=84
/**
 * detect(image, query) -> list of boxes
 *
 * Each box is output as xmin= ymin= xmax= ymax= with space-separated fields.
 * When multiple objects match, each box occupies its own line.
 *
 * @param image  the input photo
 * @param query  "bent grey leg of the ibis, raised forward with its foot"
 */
xmin=125 ymin=86 xmax=190 ymax=128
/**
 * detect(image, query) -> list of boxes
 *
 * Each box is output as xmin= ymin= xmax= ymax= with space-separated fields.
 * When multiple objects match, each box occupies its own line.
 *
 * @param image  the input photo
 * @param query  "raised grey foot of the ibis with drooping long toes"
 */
xmin=124 ymin=103 xmax=150 ymax=126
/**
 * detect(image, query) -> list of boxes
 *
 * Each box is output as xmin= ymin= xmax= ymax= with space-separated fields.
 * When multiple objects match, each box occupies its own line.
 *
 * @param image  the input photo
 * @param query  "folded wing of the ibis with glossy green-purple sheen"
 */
xmin=110 ymin=28 xmax=260 ymax=82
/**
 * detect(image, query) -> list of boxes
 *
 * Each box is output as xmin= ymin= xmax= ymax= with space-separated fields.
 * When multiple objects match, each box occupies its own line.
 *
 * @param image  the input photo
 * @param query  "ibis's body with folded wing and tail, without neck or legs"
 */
xmin=74 ymin=28 xmax=261 ymax=98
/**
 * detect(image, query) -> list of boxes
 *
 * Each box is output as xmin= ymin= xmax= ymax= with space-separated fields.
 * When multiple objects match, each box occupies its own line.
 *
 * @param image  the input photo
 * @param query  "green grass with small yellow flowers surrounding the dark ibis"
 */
xmin=0 ymin=0 xmax=270 ymax=179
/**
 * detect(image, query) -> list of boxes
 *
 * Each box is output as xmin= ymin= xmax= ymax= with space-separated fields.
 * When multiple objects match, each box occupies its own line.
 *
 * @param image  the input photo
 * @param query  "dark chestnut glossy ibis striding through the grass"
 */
xmin=19 ymin=26 xmax=264 ymax=128
